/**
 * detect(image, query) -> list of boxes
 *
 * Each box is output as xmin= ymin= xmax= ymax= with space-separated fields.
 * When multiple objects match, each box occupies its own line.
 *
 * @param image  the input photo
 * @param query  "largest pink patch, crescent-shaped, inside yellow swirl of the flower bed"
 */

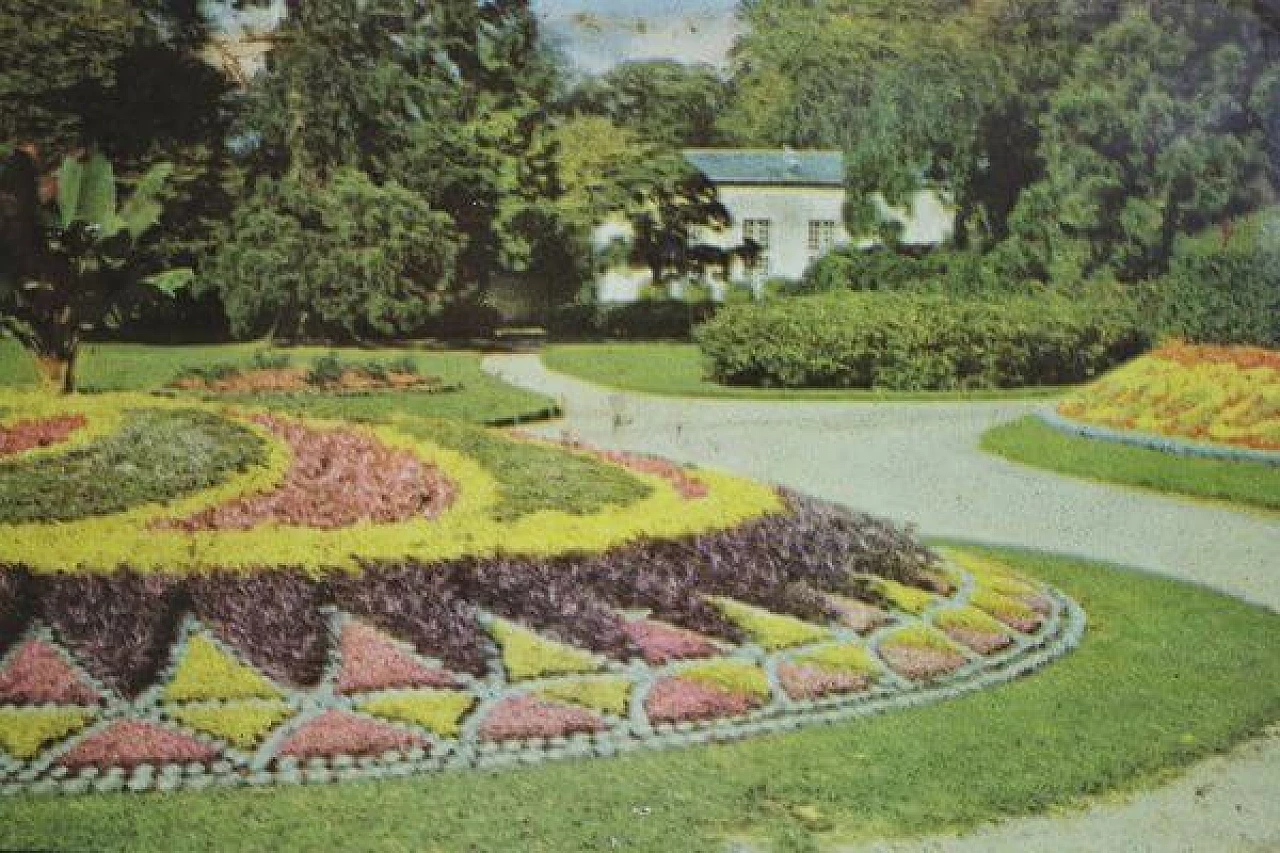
xmin=164 ymin=415 xmax=457 ymax=532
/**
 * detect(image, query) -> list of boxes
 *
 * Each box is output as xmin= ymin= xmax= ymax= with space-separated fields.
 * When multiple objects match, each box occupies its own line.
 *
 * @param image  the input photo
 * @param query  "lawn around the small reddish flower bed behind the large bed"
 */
xmin=0 ymin=338 xmax=554 ymax=423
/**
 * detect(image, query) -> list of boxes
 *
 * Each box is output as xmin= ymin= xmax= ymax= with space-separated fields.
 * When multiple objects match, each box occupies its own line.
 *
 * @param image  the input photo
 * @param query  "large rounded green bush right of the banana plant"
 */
xmin=200 ymin=169 xmax=460 ymax=338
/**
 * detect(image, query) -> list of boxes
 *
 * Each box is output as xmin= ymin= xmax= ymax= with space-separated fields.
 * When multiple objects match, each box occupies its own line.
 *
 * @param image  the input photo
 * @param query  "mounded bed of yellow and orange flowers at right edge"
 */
xmin=1059 ymin=343 xmax=1280 ymax=450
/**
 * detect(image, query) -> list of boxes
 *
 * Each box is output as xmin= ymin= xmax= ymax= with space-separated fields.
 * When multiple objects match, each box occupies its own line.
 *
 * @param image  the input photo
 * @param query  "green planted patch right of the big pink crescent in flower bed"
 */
xmin=397 ymin=418 xmax=653 ymax=521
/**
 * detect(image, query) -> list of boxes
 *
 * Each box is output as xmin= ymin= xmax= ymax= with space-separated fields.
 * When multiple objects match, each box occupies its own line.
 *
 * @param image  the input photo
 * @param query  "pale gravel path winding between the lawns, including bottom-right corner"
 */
xmin=485 ymin=355 xmax=1280 ymax=853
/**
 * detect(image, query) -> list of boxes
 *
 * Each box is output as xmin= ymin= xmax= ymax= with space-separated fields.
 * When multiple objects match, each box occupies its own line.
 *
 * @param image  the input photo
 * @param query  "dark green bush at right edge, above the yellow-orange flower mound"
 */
xmin=1152 ymin=207 xmax=1280 ymax=348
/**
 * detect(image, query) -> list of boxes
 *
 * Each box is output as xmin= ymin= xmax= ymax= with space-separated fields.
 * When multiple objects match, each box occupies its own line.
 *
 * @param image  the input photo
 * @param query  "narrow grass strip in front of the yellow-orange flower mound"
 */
xmin=982 ymin=418 xmax=1280 ymax=510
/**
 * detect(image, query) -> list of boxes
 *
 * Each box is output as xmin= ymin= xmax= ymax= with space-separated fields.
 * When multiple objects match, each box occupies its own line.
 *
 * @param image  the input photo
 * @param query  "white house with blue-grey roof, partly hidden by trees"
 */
xmin=596 ymin=149 xmax=955 ymax=302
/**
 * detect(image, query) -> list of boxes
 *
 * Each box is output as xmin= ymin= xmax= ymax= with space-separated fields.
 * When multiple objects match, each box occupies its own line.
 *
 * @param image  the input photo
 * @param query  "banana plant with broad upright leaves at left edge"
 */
xmin=0 ymin=151 xmax=191 ymax=393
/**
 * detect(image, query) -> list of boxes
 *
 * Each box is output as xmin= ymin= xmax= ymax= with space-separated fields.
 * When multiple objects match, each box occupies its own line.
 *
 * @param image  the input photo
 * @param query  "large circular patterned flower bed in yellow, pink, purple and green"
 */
xmin=0 ymin=394 xmax=1083 ymax=793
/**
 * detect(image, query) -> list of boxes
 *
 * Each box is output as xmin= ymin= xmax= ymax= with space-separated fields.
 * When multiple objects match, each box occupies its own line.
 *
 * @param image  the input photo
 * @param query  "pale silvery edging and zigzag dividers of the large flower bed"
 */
xmin=0 ymin=558 xmax=1087 ymax=795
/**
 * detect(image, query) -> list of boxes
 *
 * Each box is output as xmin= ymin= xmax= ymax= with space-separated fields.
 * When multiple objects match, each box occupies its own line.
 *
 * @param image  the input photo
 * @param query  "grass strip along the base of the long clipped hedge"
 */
xmin=543 ymin=343 xmax=1062 ymax=402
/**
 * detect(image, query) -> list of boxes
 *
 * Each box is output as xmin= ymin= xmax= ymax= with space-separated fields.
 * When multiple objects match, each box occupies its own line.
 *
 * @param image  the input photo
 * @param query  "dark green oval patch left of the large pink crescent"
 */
xmin=0 ymin=410 xmax=266 ymax=525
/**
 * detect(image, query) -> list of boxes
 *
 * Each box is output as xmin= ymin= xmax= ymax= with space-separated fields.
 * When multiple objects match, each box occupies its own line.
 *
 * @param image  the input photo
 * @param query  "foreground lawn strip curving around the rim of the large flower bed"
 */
xmin=0 ymin=551 xmax=1280 ymax=853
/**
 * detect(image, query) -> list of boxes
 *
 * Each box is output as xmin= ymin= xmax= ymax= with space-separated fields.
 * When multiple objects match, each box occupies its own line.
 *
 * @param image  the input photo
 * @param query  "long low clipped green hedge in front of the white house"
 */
xmin=695 ymin=292 xmax=1148 ymax=391
